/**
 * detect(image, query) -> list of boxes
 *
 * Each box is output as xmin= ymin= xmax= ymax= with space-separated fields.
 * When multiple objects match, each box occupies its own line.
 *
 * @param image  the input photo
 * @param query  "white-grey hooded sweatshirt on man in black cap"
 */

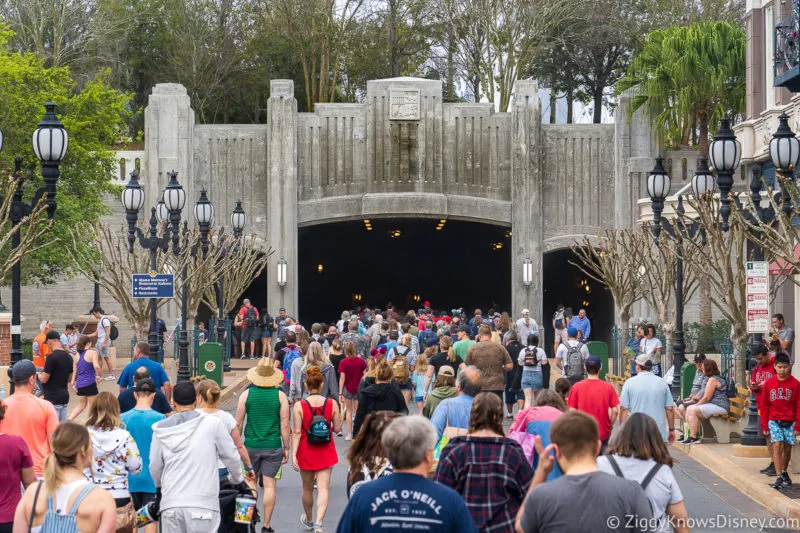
xmin=150 ymin=411 xmax=244 ymax=512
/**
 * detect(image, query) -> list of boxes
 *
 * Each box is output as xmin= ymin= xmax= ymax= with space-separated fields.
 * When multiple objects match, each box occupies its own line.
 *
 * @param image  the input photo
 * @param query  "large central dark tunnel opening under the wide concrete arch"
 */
xmin=298 ymin=218 xmax=511 ymax=324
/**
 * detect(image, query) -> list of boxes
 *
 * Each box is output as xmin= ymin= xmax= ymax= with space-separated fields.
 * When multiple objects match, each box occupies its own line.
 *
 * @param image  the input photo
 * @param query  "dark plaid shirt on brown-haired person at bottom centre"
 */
xmin=433 ymin=436 xmax=533 ymax=533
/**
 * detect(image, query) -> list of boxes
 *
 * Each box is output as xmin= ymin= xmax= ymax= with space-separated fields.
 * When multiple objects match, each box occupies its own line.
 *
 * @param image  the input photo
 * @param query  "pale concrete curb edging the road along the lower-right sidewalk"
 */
xmin=672 ymin=444 xmax=800 ymax=520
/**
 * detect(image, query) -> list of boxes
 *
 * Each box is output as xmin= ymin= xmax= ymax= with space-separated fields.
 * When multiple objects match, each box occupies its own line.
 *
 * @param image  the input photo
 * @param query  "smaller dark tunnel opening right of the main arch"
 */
xmin=543 ymin=249 xmax=614 ymax=354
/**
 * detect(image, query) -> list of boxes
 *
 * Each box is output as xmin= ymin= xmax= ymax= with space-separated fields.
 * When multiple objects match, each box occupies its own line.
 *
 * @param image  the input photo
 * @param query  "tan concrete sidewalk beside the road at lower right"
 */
xmin=672 ymin=444 xmax=800 ymax=520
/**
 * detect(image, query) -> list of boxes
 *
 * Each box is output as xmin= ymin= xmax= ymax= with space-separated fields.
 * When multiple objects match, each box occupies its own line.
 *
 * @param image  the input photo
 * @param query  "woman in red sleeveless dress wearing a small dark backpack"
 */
xmin=292 ymin=366 xmax=342 ymax=533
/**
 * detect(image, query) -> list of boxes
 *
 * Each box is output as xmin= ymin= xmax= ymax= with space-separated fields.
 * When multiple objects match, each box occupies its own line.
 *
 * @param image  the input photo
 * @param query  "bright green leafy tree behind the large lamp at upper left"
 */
xmin=0 ymin=25 xmax=130 ymax=283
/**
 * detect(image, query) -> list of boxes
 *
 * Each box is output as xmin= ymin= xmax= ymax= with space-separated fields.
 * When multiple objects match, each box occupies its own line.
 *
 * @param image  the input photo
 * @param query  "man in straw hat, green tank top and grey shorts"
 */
xmin=236 ymin=357 xmax=289 ymax=533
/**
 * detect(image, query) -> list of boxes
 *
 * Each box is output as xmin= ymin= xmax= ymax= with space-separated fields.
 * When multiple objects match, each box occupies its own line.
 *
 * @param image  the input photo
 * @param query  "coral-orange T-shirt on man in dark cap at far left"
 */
xmin=0 ymin=393 xmax=58 ymax=477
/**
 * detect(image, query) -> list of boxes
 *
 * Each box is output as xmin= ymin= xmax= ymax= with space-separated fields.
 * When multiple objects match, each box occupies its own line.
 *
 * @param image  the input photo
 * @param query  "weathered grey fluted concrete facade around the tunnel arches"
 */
xmin=12 ymin=78 xmax=656 ymax=346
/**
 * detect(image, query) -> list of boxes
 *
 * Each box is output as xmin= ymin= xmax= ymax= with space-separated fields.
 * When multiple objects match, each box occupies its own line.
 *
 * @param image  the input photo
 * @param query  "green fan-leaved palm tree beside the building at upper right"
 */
xmin=617 ymin=21 xmax=746 ymax=157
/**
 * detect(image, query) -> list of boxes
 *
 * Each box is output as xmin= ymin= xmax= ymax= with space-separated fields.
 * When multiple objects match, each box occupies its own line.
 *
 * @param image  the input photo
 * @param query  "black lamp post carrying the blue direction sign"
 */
xmin=120 ymin=170 xmax=169 ymax=362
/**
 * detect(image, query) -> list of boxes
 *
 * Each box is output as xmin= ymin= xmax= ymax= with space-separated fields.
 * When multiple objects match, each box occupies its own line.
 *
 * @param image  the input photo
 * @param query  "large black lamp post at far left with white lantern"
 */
xmin=7 ymin=102 xmax=69 ymax=365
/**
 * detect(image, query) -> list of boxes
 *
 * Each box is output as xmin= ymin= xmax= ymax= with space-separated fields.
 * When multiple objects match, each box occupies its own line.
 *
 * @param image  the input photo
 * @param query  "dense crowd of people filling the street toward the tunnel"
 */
xmin=0 ymin=300 xmax=800 ymax=533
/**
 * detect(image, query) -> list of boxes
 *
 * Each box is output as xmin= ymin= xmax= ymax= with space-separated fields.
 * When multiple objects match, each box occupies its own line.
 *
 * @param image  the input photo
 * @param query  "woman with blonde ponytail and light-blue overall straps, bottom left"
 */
xmin=13 ymin=422 xmax=117 ymax=533
